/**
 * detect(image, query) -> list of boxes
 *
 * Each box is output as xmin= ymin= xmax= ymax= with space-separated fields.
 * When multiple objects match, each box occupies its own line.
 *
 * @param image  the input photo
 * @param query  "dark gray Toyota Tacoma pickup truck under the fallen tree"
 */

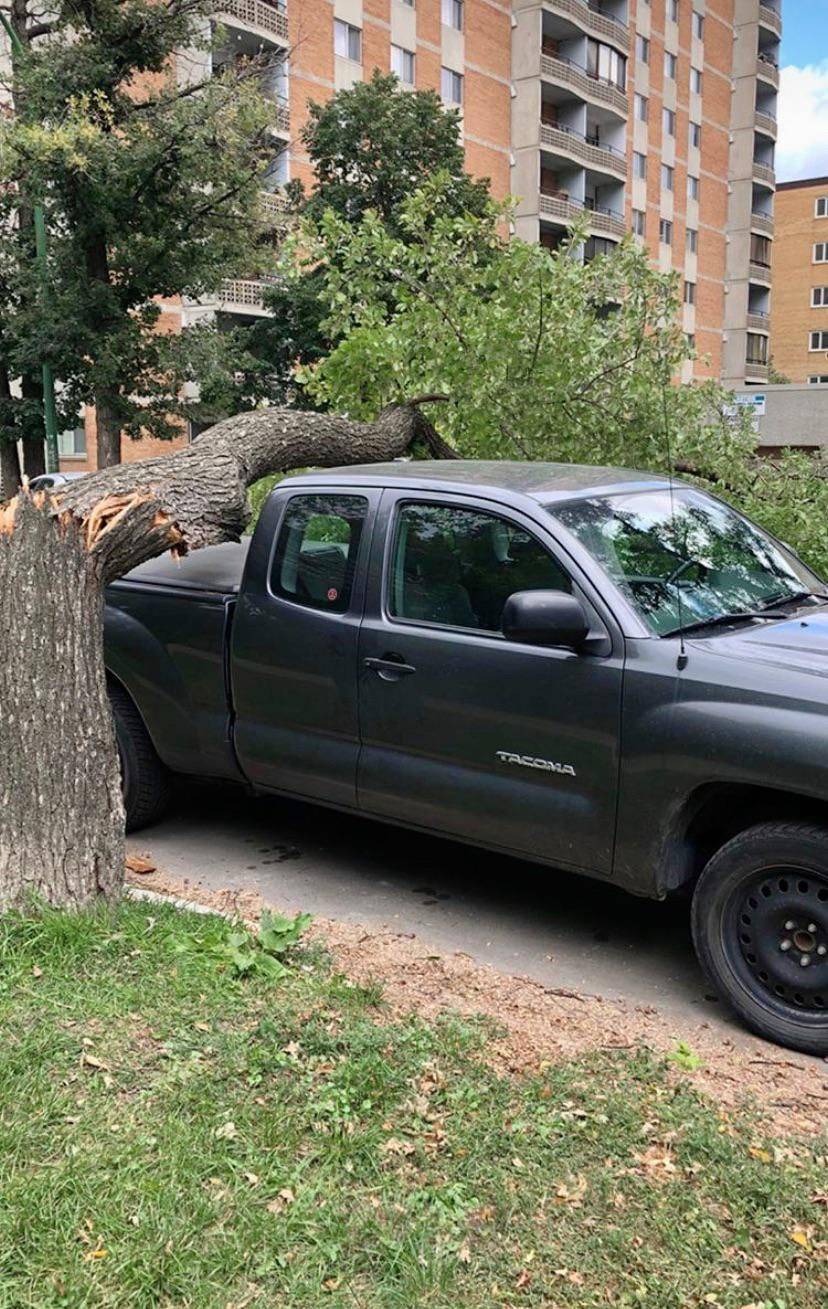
xmin=106 ymin=462 xmax=828 ymax=1054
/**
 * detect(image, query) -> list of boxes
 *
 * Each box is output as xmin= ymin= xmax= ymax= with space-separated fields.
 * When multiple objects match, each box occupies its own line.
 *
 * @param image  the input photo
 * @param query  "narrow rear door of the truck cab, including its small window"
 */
xmin=230 ymin=487 xmax=379 ymax=805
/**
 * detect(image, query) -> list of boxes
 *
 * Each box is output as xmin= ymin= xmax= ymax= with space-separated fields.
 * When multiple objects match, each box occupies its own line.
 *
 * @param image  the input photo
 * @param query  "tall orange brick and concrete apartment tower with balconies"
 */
xmin=64 ymin=0 xmax=779 ymax=467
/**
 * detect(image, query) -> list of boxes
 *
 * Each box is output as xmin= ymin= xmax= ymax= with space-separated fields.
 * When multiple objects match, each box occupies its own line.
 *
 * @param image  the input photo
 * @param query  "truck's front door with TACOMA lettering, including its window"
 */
xmin=358 ymin=491 xmax=623 ymax=876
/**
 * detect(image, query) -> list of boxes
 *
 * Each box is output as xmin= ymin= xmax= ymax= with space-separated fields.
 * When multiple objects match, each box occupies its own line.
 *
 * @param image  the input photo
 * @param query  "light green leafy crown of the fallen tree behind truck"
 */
xmin=302 ymin=178 xmax=828 ymax=571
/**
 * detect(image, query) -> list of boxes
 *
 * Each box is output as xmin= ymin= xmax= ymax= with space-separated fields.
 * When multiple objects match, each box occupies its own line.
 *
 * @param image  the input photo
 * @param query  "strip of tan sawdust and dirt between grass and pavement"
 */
xmin=127 ymin=870 xmax=828 ymax=1135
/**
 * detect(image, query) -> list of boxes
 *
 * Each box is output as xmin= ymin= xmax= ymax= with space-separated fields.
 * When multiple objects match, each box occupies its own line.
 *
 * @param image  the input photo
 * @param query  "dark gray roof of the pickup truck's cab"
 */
xmin=289 ymin=459 xmax=670 ymax=504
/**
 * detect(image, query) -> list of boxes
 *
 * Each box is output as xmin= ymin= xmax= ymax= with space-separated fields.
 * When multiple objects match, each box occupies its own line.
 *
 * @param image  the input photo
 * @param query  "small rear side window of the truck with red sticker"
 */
xmin=271 ymin=495 xmax=368 ymax=614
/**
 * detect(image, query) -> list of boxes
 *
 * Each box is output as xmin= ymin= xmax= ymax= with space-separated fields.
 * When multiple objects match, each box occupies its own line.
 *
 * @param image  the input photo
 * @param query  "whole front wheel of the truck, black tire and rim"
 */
xmin=692 ymin=822 xmax=828 ymax=1055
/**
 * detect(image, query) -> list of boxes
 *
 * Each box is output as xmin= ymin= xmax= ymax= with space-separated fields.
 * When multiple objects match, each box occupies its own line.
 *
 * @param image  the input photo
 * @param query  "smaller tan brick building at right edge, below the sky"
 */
xmin=770 ymin=177 xmax=828 ymax=386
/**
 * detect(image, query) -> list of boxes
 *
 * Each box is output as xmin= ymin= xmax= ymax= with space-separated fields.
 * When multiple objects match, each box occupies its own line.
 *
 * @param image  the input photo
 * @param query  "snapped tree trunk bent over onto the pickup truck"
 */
xmin=0 ymin=398 xmax=451 ymax=908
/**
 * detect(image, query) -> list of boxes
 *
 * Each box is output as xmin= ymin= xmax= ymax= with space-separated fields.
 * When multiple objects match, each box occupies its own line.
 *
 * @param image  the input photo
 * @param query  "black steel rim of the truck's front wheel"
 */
xmin=723 ymin=867 xmax=828 ymax=1026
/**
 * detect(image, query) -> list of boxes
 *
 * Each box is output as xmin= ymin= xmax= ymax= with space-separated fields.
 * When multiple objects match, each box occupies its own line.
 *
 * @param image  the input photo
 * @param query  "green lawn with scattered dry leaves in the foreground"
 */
xmin=0 ymin=905 xmax=828 ymax=1309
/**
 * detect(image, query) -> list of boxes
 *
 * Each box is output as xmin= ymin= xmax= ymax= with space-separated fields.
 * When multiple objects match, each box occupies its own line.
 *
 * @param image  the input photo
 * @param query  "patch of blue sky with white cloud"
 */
xmin=776 ymin=0 xmax=828 ymax=182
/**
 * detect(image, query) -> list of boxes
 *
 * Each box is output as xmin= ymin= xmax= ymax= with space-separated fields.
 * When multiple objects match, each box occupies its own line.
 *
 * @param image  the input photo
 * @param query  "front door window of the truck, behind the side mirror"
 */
xmin=388 ymin=504 xmax=572 ymax=632
